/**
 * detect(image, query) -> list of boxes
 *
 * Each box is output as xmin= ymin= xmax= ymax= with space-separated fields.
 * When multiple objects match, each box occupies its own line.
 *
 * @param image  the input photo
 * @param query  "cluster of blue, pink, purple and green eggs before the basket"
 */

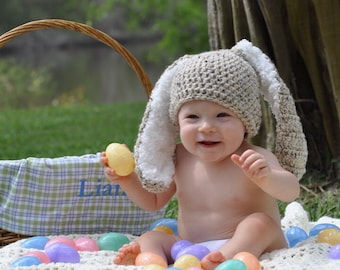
xmin=11 ymin=232 xmax=130 ymax=267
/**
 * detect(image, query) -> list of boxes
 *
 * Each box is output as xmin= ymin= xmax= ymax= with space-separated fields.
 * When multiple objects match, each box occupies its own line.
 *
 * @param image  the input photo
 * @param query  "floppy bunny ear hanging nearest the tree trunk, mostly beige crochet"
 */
xmin=231 ymin=40 xmax=308 ymax=179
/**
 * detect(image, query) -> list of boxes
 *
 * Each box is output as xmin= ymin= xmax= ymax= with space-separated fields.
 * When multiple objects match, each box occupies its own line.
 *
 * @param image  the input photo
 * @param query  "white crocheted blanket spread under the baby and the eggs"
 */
xmin=0 ymin=202 xmax=340 ymax=270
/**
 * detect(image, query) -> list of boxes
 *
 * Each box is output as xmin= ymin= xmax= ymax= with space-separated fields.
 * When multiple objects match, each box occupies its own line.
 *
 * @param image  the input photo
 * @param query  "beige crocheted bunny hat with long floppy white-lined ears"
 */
xmin=134 ymin=40 xmax=307 ymax=192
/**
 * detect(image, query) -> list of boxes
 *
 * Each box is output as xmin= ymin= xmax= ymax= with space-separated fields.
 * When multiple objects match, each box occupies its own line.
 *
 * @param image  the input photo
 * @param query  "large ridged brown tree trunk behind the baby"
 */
xmin=207 ymin=0 xmax=340 ymax=182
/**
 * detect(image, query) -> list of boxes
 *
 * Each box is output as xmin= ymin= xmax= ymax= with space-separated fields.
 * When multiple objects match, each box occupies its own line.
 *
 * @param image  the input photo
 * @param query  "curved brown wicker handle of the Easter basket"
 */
xmin=0 ymin=19 xmax=152 ymax=97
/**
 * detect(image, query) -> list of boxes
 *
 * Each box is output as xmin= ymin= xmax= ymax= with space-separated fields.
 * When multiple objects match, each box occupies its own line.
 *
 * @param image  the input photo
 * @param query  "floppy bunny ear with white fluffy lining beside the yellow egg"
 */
xmin=134 ymin=56 xmax=194 ymax=193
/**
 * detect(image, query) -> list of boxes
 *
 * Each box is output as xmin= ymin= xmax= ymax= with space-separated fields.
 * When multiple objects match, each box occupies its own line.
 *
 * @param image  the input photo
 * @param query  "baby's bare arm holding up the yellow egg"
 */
xmin=100 ymin=152 xmax=176 ymax=211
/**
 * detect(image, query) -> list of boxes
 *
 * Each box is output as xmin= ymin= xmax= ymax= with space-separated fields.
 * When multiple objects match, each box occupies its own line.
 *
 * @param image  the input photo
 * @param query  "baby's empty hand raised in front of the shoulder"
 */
xmin=231 ymin=149 xmax=271 ymax=185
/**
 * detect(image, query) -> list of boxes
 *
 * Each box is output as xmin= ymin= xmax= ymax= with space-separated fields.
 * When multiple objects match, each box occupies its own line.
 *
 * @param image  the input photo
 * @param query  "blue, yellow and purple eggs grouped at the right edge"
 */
xmin=285 ymin=223 xmax=340 ymax=260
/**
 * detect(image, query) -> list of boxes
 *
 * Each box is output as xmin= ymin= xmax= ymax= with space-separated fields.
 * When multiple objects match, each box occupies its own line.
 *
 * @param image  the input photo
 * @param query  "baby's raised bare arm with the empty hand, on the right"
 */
xmin=231 ymin=148 xmax=300 ymax=202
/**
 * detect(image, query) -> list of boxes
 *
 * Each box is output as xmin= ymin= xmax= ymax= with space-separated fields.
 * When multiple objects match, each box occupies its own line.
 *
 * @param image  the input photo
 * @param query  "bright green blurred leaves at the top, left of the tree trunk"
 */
xmin=88 ymin=0 xmax=209 ymax=61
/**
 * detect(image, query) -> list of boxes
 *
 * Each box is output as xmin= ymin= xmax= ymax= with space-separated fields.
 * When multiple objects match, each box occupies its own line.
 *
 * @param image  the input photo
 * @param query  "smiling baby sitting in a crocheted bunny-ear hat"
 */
xmin=100 ymin=40 xmax=307 ymax=269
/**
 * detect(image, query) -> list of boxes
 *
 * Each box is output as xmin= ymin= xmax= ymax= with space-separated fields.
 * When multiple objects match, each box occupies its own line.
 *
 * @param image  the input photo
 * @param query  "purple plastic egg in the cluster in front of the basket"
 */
xmin=45 ymin=243 xmax=80 ymax=263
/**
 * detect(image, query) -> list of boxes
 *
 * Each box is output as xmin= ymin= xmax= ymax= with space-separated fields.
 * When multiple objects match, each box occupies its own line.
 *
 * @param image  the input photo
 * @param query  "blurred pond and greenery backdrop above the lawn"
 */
xmin=0 ymin=0 xmax=209 ymax=109
